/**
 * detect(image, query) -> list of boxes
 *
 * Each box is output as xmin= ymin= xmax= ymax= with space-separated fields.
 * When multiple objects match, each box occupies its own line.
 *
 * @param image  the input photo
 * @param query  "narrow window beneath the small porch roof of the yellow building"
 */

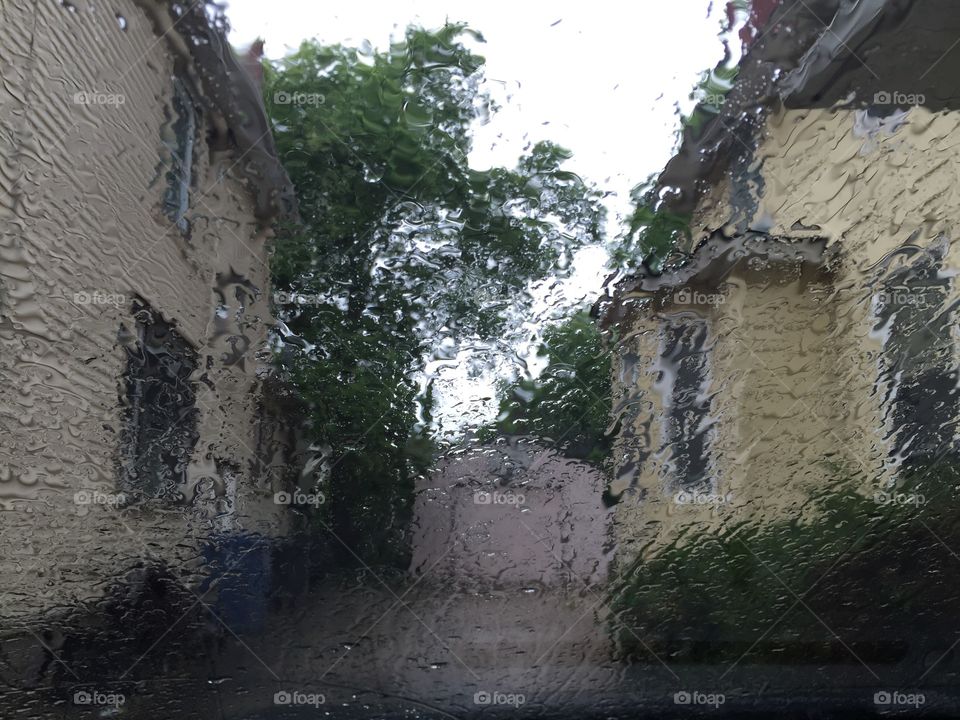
xmin=661 ymin=319 xmax=711 ymax=490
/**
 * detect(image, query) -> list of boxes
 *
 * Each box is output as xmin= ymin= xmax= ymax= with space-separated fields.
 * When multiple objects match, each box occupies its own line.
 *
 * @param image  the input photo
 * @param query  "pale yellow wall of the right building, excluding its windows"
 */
xmin=612 ymin=108 xmax=960 ymax=562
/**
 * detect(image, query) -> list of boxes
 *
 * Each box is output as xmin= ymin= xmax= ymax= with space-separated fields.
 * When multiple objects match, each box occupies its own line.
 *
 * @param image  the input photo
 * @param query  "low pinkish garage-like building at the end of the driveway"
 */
xmin=411 ymin=438 xmax=609 ymax=595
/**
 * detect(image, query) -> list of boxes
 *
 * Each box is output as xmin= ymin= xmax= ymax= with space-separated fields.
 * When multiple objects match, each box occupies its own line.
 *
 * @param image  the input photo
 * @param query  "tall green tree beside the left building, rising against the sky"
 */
xmin=264 ymin=25 xmax=603 ymax=563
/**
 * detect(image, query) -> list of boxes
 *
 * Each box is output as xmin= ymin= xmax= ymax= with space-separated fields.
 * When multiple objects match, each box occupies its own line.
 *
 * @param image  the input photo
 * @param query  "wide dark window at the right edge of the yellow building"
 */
xmin=876 ymin=255 xmax=960 ymax=462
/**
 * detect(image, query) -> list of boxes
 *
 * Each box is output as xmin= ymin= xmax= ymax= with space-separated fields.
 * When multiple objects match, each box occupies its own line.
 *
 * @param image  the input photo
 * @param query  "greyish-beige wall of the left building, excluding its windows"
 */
xmin=0 ymin=0 xmax=288 ymax=616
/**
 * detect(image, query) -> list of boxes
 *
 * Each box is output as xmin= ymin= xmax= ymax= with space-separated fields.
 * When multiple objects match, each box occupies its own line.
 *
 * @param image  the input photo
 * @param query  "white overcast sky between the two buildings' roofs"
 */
xmin=227 ymin=0 xmax=736 ymax=435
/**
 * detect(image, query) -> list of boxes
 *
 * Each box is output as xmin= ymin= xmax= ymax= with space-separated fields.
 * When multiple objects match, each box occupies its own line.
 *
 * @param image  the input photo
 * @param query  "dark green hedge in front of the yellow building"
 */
xmin=611 ymin=457 xmax=960 ymax=664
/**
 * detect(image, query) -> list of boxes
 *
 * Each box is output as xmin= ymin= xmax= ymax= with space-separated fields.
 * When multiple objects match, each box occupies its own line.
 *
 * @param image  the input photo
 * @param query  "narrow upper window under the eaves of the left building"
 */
xmin=163 ymin=77 xmax=197 ymax=235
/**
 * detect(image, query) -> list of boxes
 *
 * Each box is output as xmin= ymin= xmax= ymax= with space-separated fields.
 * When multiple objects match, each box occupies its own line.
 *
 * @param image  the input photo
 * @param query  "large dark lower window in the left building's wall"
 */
xmin=120 ymin=303 xmax=199 ymax=498
